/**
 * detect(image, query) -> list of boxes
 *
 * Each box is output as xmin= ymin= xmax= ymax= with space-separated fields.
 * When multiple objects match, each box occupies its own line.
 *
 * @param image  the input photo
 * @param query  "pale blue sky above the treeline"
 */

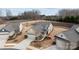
xmin=0 ymin=8 xmax=61 ymax=16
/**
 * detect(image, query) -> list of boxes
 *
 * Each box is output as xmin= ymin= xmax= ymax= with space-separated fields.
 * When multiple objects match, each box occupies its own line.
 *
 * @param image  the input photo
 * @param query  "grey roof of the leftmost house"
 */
xmin=0 ymin=20 xmax=26 ymax=32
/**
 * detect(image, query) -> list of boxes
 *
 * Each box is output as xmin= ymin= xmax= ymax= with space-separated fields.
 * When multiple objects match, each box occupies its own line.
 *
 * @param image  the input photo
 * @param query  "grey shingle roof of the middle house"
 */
xmin=27 ymin=22 xmax=50 ymax=35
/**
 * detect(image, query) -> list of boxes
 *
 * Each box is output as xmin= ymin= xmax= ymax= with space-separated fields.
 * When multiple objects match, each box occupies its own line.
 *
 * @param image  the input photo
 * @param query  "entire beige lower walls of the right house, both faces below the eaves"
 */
xmin=56 ymin=38 xmax=77 ymax=50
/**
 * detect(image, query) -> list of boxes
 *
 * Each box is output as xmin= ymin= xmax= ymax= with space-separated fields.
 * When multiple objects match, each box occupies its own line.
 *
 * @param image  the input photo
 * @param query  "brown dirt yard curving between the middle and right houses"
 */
xmin=30 ymin=26 xmax=68 ymax=49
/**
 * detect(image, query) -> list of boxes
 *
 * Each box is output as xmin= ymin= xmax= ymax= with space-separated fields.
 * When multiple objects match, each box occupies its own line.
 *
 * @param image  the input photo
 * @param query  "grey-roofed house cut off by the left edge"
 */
xmin=0 ymin=23 xmax=19 ymax=36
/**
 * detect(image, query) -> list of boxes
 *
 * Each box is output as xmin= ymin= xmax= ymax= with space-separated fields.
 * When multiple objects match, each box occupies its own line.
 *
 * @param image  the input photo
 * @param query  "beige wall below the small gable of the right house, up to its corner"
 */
xmin=56 ymin=38 xmax=70 ymax=50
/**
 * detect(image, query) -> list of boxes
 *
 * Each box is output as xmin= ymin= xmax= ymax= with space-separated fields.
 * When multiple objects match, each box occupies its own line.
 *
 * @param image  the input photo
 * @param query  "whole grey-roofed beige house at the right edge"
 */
xmin=55 ymin=25 xmax=79 ymax=50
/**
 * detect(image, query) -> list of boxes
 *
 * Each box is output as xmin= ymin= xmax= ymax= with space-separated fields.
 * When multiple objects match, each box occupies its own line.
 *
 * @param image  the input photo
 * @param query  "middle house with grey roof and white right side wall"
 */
xmin=27 ymin=22 xmax=53 ymax=40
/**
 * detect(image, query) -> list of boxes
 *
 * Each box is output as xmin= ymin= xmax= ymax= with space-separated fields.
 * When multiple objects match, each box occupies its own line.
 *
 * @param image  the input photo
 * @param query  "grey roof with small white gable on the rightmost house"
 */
xmin=56 ymin=25 xmax=79 ymax=42
